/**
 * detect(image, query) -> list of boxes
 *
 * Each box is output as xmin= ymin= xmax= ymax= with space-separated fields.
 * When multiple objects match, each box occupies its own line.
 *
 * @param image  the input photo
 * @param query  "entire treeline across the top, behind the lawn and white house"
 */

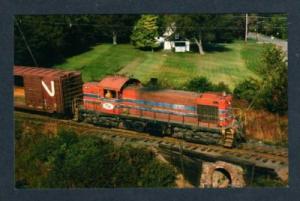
xmin=14 ymin=14 xmax=287 ymax=67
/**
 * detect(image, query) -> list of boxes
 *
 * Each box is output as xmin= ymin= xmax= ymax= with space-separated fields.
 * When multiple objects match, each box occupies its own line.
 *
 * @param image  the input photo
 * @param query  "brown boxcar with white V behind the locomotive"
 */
xmin=14 ymin=66 xmax=83 ymax=114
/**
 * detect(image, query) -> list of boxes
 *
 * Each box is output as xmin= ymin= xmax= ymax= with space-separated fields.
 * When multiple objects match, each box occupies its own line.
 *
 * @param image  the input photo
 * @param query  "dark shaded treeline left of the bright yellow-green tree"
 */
xmin=14 ymin=15 xmax=139 ymax=67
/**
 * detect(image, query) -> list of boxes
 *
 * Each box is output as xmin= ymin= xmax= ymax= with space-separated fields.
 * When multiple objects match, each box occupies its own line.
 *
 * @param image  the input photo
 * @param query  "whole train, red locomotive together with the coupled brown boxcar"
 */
xmin=14 ymin=67 xmax=243 ymax=147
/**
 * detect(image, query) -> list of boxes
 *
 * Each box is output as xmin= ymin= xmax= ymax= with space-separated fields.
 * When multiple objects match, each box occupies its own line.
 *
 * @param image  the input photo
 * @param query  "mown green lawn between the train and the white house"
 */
xmin=57 ymin=41 xmax=262 ymax=89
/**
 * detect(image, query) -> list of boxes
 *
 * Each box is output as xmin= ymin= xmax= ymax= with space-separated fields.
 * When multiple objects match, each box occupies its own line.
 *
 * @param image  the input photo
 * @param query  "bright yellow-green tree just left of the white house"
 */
xmin=131 ymin=15 xmax=159 ymax=50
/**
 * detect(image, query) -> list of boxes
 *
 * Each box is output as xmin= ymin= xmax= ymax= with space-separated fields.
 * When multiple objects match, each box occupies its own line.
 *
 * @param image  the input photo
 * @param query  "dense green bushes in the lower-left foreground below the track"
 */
xmin=15 ymin=121 xmax=176 ymax=188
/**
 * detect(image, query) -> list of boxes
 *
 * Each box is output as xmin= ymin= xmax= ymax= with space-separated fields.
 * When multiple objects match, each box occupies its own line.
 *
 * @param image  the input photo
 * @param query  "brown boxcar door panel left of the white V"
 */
xmin=24 ymin=76 xmax=44 ymax=110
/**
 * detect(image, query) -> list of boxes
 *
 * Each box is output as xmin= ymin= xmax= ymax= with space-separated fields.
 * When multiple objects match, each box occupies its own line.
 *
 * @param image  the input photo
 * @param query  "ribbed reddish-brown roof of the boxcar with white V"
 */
xmin=14 ymin=66 xmax=80 ymax=78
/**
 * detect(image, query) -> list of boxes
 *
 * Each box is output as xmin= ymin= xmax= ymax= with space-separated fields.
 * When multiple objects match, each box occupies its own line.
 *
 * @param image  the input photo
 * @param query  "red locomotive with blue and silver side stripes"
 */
xmin=79 ymin=76 xmax=242 ymax=147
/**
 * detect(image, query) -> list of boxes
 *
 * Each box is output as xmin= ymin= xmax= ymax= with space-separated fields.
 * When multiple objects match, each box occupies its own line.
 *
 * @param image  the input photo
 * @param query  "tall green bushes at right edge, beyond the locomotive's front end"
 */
xmin=234 ymin=45 xmax=288 ymax=115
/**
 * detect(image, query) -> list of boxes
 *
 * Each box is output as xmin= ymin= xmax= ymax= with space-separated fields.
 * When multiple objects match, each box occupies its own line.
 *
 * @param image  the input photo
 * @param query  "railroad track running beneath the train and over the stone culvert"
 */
xmin=15 ymin=112 xmax=288 ymax=171
